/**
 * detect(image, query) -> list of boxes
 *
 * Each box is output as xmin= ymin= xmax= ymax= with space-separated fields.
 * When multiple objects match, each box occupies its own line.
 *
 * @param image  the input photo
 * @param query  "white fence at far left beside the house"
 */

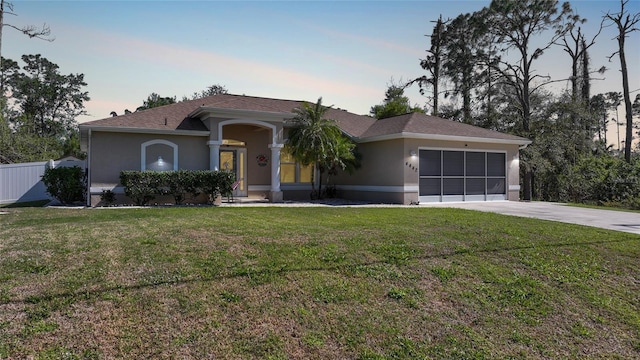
xmin=0 ymin=160 xmax=85 ymax=204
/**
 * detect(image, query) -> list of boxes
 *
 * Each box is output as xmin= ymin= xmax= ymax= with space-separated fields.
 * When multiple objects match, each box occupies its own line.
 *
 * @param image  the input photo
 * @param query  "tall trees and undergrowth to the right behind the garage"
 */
xmin=396 ymin=0 xmax=640 ymax=208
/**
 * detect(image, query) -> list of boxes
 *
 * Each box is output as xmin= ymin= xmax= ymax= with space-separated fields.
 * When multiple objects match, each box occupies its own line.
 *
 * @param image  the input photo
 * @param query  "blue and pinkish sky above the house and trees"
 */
xmin=2 ymin=0 xmax=640 ymax=146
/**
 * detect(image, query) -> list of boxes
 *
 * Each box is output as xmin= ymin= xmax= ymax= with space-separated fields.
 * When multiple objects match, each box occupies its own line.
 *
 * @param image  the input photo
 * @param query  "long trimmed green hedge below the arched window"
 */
xmin=120 ymin=170 xmax=235 ymax=206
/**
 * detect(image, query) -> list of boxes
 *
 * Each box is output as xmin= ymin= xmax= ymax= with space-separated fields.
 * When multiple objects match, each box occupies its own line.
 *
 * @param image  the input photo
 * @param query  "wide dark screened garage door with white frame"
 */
xmin=419 ymin=150 xmax=507 ymax=202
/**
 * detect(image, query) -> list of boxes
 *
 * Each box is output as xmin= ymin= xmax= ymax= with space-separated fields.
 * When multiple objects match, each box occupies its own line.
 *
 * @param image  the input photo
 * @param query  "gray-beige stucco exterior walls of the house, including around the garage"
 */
xmin=89 ymin=126 xmax=519 ymax=204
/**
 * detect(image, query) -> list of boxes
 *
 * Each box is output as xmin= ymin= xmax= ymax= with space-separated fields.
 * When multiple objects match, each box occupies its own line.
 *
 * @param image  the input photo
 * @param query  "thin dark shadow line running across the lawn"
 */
xmin=0 ymin=235 xmax=640 ymax=305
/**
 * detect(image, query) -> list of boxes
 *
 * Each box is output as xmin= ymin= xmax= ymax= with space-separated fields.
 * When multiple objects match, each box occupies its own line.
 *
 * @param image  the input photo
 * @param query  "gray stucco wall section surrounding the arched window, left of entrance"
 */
xmin=89 ymin=131 xmax=209 ymax=186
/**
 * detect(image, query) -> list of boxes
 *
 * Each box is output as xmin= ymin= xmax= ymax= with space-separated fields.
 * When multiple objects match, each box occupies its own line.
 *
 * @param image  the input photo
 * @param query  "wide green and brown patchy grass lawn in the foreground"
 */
xmin=0 ymin=207 xmax=640 ymax=359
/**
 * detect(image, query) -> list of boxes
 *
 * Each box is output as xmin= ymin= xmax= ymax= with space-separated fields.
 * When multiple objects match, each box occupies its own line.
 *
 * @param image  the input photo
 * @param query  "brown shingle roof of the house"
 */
xmin=81 ymin=94 xmax=530 ymax=144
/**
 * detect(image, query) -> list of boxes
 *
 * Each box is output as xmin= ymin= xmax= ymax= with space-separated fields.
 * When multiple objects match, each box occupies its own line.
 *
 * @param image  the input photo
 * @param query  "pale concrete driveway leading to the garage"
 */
xmin=421 ymin=201 xmax=640 ymax=235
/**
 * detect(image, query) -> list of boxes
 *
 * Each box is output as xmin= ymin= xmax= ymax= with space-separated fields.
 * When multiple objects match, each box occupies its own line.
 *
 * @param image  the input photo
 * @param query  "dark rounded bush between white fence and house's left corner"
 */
xmin=42 ymin=166 xmax=86 ymax=205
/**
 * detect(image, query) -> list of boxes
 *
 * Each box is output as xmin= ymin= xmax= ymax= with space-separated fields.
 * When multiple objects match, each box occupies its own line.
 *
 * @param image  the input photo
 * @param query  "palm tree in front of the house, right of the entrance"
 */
xmin=285 ymin=98 xmax=354 ymax=198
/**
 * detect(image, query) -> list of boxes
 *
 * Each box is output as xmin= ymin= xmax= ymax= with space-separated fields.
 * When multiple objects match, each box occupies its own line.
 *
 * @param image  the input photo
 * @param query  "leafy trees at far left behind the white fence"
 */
xmin=0 ymin=55 xmax=89 ymax=163
